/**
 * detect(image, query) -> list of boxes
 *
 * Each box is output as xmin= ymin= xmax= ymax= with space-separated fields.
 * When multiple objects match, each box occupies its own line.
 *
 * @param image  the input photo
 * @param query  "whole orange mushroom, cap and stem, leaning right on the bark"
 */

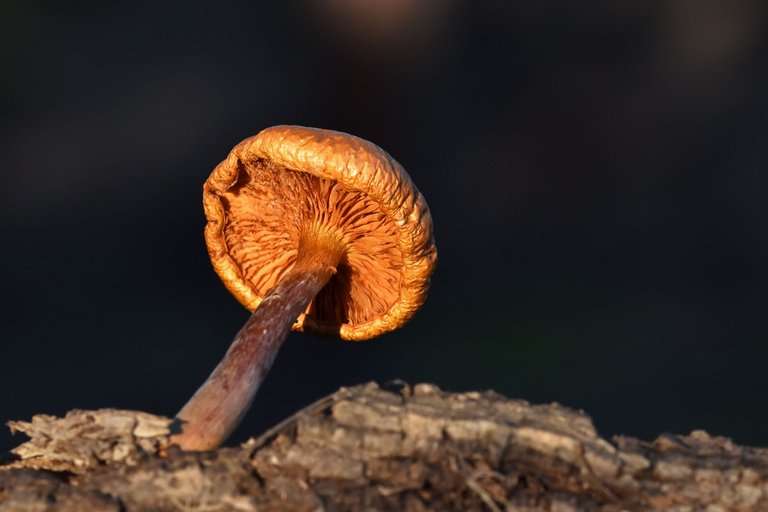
xmin=171 ymin=126 xmax=437 ymax=451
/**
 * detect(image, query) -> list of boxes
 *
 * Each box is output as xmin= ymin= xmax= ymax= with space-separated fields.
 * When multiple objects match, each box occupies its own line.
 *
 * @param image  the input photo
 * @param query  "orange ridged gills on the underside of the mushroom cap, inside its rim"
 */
xmin=219 ymin=159 xmax=403 ymax=326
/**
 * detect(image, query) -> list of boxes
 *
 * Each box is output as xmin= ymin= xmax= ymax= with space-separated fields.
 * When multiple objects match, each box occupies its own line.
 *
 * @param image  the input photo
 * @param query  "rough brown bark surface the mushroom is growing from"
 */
xmin=0 ymin=384 xmax=768 ymax=512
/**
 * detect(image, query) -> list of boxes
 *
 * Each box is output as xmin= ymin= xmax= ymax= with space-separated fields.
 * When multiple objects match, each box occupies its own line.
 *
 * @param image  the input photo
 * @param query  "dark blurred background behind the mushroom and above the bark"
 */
xmin=0 ymin=0 xmax=768 ymax=451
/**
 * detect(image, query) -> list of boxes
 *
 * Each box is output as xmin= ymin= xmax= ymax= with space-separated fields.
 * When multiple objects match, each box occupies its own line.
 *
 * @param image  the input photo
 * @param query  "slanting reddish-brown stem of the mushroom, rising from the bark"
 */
xmin=171 ymin=236 xmax=341 ymax=451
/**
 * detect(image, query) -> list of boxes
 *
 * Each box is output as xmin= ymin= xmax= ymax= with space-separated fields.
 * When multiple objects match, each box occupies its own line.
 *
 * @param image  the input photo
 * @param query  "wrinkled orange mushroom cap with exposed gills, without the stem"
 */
xmin=203 ymin=126 xmax=437 ymax=340
